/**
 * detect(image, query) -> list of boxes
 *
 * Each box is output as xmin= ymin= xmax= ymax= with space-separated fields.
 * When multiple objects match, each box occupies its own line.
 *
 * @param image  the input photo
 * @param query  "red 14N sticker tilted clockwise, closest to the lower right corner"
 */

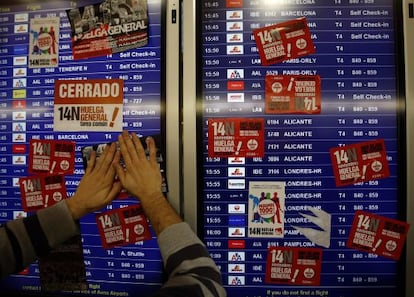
xmin=347 ymin=210 xmax=410 ymax=260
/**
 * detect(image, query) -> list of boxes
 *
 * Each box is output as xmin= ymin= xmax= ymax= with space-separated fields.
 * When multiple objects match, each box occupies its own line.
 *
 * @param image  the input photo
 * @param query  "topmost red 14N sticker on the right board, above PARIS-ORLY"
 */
xmin=253 ymin=18 xmax=315 ymax=66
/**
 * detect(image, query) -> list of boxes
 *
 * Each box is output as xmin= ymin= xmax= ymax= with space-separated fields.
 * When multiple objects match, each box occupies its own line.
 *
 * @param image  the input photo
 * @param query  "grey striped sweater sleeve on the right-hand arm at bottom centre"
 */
xmin=153 ymin=222 xmax=226 ymax=297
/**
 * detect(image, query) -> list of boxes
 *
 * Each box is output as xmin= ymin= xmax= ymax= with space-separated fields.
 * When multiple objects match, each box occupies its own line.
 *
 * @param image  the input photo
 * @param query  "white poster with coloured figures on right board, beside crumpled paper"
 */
xmin=247 ymin=181 xmax=285 ymax=238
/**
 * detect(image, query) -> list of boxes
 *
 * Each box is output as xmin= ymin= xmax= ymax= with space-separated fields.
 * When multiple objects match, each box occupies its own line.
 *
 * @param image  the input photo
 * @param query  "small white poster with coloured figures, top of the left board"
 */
xmin=29 ymin=17 xmax=60 ymax=68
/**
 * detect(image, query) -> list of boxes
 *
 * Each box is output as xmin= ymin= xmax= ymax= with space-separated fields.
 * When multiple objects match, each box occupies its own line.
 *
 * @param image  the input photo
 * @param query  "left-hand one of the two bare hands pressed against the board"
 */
xmin=66 ymin=143 xmax=122 ymax=220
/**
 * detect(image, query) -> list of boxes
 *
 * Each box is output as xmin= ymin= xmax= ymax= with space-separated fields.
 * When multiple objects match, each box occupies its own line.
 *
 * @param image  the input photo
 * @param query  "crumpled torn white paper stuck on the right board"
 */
xmin=293 ymin=207 xmax=332 ymax=248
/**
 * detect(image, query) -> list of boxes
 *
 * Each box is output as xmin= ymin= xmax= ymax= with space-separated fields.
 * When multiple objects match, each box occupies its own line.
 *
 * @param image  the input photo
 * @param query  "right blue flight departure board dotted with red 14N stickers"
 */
xmin=197 ymin=0 xmax=408 ymax=297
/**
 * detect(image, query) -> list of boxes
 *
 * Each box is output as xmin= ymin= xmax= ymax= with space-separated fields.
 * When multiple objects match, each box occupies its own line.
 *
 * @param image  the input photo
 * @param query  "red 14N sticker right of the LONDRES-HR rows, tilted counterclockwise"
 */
xmin=330 ymin=139 xmax=390 ymax=187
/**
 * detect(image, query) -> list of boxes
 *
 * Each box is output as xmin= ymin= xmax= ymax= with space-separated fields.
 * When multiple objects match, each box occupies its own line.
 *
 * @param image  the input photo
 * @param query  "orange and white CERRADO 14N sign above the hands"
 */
xmin=53 ymin=79 xmax=124 ymax=133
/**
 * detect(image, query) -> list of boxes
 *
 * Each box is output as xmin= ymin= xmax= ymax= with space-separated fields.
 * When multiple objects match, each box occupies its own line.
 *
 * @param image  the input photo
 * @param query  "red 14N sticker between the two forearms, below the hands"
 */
xmin=96 ymin=204 xmax=151 ymax=249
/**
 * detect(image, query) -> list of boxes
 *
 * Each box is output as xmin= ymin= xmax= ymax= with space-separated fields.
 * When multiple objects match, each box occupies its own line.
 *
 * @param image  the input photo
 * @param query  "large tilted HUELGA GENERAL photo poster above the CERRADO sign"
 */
xmin=67 ymin=0 xmax=149 ymax=60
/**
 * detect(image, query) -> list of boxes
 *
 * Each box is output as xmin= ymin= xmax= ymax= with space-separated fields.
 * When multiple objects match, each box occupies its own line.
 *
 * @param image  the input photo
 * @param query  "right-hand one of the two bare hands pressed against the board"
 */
xmin=114 ymin=131 xmax=163 ymax=202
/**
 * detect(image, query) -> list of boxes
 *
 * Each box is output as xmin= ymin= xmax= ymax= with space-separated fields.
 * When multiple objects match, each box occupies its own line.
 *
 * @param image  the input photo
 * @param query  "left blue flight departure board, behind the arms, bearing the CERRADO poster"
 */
xmin=0 ymin=0 xmax=165 ymax=296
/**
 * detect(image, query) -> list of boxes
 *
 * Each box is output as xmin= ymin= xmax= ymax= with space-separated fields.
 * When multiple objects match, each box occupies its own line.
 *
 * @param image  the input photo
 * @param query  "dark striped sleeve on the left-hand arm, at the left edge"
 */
xmin=0 ymin=201 xmax=79 ymax=278
